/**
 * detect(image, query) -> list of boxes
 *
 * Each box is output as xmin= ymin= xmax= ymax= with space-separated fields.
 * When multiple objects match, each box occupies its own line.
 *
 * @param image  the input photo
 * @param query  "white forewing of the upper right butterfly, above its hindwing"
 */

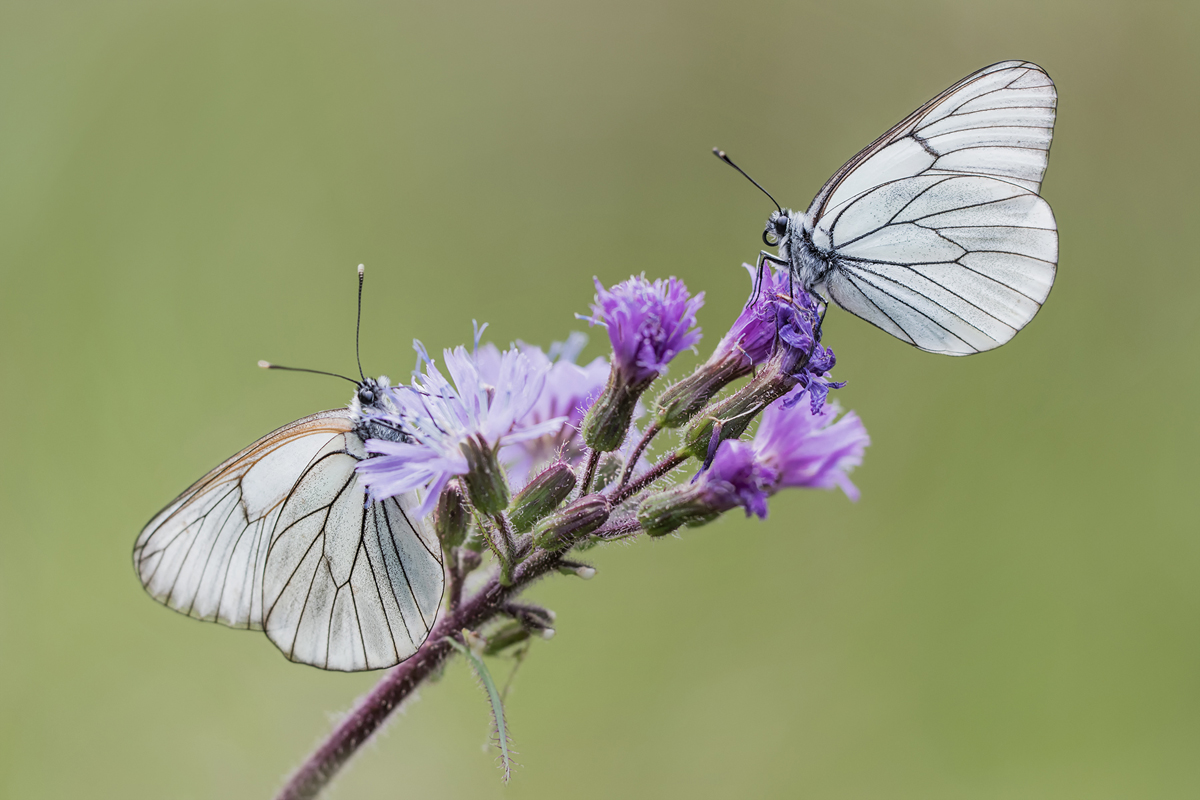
xmin=809 ymin=61 xmax=1057 ymax=219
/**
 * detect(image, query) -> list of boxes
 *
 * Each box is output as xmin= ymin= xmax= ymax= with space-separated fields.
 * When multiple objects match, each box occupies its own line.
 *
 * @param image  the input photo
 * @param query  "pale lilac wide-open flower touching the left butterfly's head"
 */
xmin=358 ymin=342 xmax=563 ymax=516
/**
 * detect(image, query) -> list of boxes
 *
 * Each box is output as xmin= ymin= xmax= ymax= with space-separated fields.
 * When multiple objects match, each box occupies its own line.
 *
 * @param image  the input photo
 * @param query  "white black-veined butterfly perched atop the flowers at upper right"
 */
xmin=714 ymin=61 xmax=1058 ymax=355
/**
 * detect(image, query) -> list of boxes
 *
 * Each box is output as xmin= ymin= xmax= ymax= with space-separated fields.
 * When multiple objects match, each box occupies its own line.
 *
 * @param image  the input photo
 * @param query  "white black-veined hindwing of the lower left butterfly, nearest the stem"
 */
xmin=263 ymin=433 xmax=444 ymax=672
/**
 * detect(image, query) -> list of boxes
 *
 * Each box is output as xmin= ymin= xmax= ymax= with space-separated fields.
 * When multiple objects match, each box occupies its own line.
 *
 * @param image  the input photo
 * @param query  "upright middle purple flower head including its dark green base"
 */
xmin=583 ymin=275 xmax=704 ymax=452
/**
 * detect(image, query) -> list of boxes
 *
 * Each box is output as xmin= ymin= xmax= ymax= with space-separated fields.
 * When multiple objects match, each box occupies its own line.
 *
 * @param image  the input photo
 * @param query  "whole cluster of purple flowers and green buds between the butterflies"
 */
xmin=358 ymin=271 xmax=870 ymax=575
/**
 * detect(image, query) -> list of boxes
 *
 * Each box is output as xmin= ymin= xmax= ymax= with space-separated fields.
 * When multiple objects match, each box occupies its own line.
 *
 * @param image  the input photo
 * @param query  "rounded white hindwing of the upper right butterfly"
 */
xmin=815 ymin=174 xmax=1058 ymax=355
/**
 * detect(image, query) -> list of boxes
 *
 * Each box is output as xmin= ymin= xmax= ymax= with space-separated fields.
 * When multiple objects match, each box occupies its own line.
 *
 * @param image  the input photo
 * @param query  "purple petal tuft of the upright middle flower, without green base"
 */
xmin=581 ymin=275 xmax=704 ymax=386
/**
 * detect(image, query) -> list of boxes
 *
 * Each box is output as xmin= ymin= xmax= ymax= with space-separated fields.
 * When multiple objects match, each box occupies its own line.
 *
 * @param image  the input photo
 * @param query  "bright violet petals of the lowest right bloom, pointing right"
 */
xmin=753 ymin=385 xmax=871 ymax=500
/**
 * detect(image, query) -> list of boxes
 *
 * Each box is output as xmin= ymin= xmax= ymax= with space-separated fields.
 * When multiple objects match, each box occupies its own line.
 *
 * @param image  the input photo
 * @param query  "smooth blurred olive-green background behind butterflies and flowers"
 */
xmin=0 ymin=0 xmax=1200 ymax=800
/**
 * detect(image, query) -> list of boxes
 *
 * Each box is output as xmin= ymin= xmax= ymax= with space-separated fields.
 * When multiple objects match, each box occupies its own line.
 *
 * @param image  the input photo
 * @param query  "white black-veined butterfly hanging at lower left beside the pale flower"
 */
xmin=133 ymin=266 xmax=445 ymax=672
